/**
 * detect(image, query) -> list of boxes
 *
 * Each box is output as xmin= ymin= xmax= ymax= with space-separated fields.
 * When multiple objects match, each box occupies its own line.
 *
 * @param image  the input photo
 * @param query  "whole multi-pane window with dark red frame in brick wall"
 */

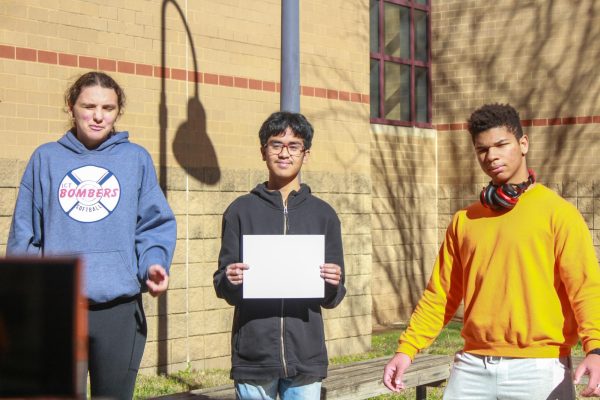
xmin=370 ymin=0 xmax=431 ymax=127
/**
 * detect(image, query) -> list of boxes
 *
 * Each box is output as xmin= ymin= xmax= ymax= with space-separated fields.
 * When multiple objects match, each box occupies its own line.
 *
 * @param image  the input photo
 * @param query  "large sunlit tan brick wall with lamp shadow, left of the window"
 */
xmin=0 ymin=0 xmax=372 ymax=373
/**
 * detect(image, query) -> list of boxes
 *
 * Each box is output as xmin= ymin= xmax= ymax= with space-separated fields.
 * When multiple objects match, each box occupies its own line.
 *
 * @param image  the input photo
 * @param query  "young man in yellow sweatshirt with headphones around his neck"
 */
xmin=383 ymin=104 xmax=600 ymax=400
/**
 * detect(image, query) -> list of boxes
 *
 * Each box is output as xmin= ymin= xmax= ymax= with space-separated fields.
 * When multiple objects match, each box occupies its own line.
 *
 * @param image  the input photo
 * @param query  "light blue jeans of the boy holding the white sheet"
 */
xmin=235 ymin=375 xmax=321 ymax=400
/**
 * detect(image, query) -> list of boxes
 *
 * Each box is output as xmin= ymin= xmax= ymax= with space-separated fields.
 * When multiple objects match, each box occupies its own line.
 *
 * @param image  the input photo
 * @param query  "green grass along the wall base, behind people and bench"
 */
xmin=134 ymin=322 xmax=583 ymax=400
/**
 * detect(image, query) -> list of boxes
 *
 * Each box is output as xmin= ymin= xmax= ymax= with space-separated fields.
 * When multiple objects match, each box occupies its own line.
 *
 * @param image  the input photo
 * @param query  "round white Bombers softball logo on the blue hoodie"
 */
xmin=58 ymin=165 xmax=121 ymax=222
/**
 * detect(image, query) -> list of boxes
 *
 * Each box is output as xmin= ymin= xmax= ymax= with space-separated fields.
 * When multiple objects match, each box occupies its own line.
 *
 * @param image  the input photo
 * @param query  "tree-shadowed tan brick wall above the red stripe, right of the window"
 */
xmin=432 ymin=0 xmax=600 ymax=124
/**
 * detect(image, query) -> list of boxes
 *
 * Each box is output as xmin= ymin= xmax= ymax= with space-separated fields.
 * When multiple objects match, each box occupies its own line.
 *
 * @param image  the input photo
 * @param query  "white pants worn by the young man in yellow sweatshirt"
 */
xmin=444 ymin=351 xmax=575 ymax=400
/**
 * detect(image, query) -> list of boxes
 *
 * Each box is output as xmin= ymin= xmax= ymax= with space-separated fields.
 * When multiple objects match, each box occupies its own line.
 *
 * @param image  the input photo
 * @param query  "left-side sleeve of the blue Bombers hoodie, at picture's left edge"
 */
xmin=6 ymin=154 xmax=43 ymax=256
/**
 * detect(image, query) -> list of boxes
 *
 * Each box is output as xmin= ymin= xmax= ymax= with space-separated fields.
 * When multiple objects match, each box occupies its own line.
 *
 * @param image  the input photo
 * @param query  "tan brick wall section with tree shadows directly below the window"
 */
xmin=371 ymin=125 xmax=438 ymax=325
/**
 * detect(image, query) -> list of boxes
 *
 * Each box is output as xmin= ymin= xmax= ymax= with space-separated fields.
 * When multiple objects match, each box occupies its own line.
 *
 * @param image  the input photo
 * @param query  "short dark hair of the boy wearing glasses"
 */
xmin=258 ymin=111 xmax=314 ymax=150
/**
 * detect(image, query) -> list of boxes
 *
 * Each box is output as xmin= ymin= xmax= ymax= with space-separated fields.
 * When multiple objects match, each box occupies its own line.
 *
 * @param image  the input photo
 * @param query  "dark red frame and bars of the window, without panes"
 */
xmin=370 ymin=0 xmax=433 ymax=128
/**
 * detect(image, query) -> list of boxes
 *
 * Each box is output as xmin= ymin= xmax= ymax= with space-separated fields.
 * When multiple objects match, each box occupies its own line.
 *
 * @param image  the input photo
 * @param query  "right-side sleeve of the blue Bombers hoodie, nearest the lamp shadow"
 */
xmin=135 ymin=155 xmax=177 ymax=282
